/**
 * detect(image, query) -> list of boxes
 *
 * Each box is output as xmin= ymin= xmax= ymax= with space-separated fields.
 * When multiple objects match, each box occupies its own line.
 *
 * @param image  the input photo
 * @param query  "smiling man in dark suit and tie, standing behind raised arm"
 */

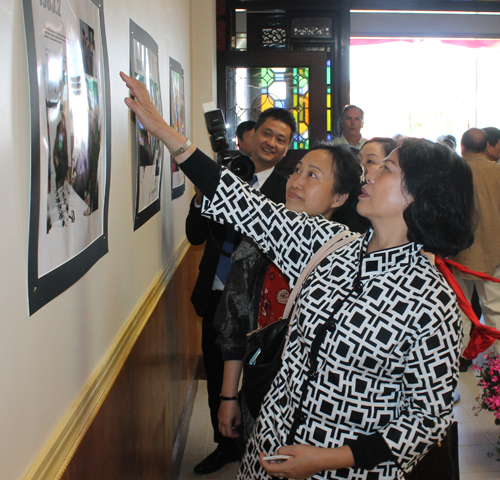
xmin=186 ymin=108 xmax=297 ymax=474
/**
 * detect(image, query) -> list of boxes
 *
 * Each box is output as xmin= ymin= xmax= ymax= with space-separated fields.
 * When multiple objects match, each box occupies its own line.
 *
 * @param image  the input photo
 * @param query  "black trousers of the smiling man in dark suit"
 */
xmin=201 ymin=290 xmax=237 ymax=448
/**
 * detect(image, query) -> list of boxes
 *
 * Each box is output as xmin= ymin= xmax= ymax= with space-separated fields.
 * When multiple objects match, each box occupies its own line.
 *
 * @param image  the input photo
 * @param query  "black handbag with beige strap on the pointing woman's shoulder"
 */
xmin=241 ymin=230 xmax=360 ymax=418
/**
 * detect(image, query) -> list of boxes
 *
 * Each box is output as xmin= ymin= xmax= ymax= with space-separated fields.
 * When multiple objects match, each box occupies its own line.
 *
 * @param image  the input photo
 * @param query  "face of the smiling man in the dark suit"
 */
xmin=252 ymin=118 xmax=292 ymax=172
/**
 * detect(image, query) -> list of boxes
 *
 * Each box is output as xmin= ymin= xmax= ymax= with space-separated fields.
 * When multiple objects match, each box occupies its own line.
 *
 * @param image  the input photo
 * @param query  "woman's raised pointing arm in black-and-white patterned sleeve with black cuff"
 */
xmin=120 ymin=72 xmax=346 ymax=286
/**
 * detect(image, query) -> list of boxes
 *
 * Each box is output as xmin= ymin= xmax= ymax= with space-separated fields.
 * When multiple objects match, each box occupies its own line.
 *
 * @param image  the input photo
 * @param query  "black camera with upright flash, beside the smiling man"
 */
xmin=205 ymin=108 xmax=255 ymax=182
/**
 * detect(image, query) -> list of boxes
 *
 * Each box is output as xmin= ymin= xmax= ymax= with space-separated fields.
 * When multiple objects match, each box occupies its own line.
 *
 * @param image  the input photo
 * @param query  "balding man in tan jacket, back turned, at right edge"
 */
xmin=453 ymin=128 xmax=500 ymax=371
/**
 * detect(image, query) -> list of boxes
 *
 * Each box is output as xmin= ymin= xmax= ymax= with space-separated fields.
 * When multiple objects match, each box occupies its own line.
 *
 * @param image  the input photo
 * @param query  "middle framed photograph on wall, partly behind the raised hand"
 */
xmin=130 ymin=20 xmax=163 ymax=230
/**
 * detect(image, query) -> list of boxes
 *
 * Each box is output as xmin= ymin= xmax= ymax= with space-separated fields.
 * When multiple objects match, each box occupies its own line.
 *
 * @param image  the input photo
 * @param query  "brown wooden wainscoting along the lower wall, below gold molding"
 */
xmin=59 ymin=247 xmax=203 ymax=480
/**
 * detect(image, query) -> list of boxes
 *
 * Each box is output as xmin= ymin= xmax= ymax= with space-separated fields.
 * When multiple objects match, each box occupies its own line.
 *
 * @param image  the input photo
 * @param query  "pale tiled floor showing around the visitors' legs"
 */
xmin=179 ymin=362 xmax=500 ymax=480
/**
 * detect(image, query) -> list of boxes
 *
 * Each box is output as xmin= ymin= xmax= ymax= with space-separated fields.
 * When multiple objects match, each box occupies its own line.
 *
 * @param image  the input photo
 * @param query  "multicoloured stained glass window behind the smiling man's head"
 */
xmin=225 ymin=67 xmax=309 ymax=149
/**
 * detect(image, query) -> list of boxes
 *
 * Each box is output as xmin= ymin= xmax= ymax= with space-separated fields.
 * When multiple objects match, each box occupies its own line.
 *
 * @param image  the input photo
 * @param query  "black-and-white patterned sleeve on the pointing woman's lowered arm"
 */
xmin=380 ymin=284 xmax=463 ymax=472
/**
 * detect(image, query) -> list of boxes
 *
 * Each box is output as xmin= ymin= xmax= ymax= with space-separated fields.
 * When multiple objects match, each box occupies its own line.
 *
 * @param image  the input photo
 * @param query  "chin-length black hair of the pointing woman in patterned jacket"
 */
xmin=398 ymin=138 xmax=476 ymax=256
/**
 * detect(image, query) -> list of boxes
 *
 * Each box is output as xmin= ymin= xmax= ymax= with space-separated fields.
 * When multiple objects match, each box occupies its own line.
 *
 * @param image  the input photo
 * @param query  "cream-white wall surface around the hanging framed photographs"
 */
xmin=0 ymin=0 xmax=215 ymax=480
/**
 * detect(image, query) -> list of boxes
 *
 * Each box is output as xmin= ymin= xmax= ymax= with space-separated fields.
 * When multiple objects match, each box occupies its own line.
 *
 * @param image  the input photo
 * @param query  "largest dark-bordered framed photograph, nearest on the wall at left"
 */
xmin=23 ymin=0 xmax=111 ymax=315
